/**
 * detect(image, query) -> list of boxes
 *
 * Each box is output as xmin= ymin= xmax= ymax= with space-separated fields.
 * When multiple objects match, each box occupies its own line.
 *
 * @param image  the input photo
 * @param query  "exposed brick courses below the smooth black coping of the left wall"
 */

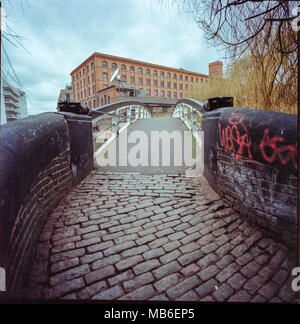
xmin=8 ymin=150 xmax=72 ymax=290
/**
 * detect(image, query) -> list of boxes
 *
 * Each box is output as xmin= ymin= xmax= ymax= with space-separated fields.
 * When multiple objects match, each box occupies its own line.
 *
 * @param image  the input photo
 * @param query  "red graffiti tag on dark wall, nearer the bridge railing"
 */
xmin=219 ymin=112 xmax=252 ymax=161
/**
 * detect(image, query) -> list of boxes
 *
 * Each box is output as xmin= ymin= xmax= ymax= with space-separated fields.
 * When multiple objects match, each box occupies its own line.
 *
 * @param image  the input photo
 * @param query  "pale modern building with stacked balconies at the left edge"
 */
xmin=1 ymin=79 xmax=28 ymax=124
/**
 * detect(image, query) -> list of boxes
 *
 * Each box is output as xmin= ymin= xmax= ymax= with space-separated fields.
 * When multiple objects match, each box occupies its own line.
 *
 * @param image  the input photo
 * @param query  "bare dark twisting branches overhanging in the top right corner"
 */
xmin=168 ymin=0 xmax=300 ymax=83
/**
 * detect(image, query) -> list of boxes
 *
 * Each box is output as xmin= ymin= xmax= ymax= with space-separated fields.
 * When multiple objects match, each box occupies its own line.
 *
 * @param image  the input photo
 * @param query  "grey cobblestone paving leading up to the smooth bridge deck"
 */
xmin=28 ymin=171 xmax=295 ymax=302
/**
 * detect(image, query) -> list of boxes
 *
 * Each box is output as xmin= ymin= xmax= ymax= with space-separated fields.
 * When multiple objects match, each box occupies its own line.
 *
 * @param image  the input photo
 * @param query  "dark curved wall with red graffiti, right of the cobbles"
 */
xmin=202 ymin=108 xmax=298 ymax=247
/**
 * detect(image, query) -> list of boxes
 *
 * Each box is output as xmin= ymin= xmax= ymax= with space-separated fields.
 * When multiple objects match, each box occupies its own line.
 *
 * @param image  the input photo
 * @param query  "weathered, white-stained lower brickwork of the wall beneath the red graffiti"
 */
xmin=217 ymin=147 xmax=298 ymax=247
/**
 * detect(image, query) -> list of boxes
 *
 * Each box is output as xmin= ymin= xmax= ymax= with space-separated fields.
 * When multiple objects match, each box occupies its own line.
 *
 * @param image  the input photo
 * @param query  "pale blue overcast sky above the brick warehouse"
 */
xmin=2 ymin=0 xmax=224 ymax=114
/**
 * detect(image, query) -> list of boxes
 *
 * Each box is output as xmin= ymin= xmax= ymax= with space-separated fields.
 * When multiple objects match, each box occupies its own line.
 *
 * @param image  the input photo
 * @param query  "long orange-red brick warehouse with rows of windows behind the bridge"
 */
xmin=71 ymin=52 xmax=223 ymax=108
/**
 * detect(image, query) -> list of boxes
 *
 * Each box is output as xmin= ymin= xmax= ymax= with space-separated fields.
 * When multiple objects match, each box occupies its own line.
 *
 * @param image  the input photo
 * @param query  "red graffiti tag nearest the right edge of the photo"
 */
xmin=259 ymin=129 xmax=298 ymax=170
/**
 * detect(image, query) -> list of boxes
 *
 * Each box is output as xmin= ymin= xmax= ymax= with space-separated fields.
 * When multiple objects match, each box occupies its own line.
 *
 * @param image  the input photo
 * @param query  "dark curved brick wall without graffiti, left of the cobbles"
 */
xmin=0 ymin=113 xmax=93 ymax=297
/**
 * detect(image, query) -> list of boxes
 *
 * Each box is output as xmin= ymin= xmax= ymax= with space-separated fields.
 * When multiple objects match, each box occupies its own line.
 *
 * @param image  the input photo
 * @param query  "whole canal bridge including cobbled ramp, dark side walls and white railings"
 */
xmin=0 ymin=99 xmax=298 ymax=302
